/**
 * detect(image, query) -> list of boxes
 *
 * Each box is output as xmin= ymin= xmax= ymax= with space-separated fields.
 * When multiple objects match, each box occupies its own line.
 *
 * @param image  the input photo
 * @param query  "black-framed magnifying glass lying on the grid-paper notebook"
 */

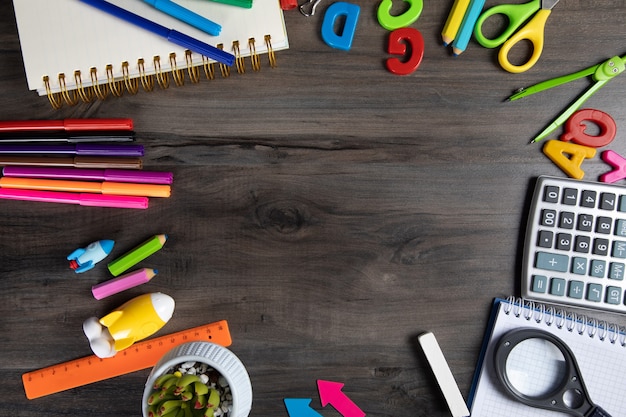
xmin=494 ymin=329 xmax=611 ymax=417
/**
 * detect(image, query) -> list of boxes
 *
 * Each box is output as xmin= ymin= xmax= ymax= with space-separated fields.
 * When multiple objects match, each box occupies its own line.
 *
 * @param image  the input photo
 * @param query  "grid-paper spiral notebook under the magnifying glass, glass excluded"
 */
xmin=468 ymin=298 xmax=626 ymax=417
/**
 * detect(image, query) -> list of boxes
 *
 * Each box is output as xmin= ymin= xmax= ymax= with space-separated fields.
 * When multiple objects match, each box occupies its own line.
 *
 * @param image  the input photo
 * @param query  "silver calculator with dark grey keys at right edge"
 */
xmin=522 ymin=176 xmax=626 ymax=313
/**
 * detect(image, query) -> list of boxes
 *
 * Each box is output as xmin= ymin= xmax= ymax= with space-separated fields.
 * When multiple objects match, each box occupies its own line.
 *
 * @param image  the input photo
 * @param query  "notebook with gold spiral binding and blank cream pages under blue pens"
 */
xmin=13 ymin=0 xmax=289 ymax=108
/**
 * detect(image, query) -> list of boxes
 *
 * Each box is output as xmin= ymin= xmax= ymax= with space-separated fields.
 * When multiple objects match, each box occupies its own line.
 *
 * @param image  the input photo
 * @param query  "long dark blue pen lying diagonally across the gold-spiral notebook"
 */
xmin=80 ymin=0 xmax=235 ymax=66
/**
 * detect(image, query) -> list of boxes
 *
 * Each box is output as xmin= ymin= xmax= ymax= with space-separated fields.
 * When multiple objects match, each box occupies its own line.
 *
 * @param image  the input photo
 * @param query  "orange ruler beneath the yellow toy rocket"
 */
xmin=22 ymin=320 xmax=232 ymax=400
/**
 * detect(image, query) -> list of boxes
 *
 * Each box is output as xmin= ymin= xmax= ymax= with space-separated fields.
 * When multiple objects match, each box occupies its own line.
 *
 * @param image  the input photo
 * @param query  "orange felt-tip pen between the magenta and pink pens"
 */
xmin=0 ymin=177 xmax=170 ymax=197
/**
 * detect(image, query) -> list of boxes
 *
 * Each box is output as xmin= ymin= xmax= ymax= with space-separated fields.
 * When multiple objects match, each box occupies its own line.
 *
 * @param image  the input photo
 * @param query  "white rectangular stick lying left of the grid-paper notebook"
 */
xmin=417 ymin=332 xmax=470 ymax=417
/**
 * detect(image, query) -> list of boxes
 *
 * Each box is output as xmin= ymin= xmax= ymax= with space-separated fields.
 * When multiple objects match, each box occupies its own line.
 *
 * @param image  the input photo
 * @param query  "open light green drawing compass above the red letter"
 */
xmin=507 ymin=55 xmax=626 ymax=143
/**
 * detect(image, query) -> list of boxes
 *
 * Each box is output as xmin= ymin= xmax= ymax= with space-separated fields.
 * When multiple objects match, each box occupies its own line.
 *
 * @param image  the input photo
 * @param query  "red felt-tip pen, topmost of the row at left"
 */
xmin=0 ymin=119 xmax=133 ymax=132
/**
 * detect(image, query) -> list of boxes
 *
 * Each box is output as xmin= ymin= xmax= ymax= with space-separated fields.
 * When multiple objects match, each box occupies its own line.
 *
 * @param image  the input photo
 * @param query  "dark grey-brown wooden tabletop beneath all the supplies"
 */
xmin=0 ymin=0 xmax=626 ymax=417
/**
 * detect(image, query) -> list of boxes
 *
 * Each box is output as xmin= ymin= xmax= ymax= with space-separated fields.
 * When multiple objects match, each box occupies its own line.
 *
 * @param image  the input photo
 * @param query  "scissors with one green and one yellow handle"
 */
xmin=474 ymin=0 xmax=559 ymax=73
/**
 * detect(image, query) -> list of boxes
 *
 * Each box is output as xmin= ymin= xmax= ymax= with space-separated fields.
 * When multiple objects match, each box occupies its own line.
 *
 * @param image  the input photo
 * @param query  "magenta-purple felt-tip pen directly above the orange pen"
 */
xmin=2 ymin=166 xmax=174 ymax=184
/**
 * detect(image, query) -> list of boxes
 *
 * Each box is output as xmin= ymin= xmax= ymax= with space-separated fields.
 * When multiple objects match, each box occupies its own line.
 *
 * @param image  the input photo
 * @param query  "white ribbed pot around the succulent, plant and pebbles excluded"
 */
xmin=141 ymin=342 xmax=252 ymax=417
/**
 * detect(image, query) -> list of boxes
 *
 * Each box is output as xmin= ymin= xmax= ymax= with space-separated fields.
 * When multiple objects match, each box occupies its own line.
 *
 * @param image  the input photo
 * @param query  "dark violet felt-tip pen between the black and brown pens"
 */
xmin=0 ymin=143 xmax=143 ymax=156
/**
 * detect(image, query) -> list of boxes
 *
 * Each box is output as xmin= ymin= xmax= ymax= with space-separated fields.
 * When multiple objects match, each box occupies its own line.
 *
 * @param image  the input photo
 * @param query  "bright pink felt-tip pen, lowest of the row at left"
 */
xmin=0 ymin=188 xmax=148 ymax=209
